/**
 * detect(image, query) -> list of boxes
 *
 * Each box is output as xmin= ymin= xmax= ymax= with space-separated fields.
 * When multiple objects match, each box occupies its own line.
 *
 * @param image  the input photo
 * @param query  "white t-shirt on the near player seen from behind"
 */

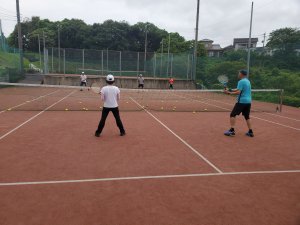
xmin=100 ymin=85 xmax=120 ymax=108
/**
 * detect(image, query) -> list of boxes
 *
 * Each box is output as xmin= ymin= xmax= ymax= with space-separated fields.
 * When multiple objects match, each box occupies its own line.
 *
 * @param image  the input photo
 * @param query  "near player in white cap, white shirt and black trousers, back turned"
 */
xmin=95 ymin=74 xmax=125 ymax=137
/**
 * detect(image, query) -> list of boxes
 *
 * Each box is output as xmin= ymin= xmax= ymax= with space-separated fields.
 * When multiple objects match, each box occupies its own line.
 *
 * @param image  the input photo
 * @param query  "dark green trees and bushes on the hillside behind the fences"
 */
xmin=4 ymin=17 xmax=300 ymax=107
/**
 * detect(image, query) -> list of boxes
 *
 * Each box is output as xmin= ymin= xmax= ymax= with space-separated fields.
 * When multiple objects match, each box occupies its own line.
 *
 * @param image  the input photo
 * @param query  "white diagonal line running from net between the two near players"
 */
xmin=130 ymin=97 xmax=223 ymax=173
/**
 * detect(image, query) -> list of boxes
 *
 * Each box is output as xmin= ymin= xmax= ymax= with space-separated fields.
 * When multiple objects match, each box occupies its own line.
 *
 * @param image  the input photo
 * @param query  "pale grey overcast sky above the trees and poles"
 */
xmin=0 ymin=0 xmax=300 ymax=47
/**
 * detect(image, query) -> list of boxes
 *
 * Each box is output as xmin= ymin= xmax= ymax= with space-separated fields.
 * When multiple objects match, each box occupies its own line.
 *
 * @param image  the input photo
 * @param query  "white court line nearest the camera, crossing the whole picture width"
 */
xmin=0 ymin=170 xmax=300 ymax=187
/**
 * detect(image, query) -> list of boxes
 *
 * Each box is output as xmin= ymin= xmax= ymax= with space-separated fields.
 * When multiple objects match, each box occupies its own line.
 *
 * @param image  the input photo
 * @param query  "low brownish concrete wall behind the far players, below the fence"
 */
xmin=43 ymin=75 xmax=196 ymax=89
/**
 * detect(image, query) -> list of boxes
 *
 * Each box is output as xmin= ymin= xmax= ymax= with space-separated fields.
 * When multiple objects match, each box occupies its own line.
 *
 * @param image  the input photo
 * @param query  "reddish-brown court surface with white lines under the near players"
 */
xmin=0 ymin=86 xmax=300 ymax=225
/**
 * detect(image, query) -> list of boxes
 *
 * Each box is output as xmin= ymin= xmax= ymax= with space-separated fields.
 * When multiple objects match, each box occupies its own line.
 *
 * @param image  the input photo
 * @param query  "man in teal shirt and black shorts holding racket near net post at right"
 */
xmin=224 ymin=70 xmax=254 ymax=137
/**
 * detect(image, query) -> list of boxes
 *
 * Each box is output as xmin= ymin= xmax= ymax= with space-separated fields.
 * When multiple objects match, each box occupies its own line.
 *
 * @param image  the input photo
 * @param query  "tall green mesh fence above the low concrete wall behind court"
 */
xmin=37 ymin=48 xmax=193 ymax=80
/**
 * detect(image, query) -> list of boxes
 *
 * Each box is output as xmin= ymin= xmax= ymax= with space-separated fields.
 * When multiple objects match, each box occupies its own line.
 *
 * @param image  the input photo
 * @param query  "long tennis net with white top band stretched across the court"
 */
xmin=0 ymin=82 xmax=282 ymax=112
